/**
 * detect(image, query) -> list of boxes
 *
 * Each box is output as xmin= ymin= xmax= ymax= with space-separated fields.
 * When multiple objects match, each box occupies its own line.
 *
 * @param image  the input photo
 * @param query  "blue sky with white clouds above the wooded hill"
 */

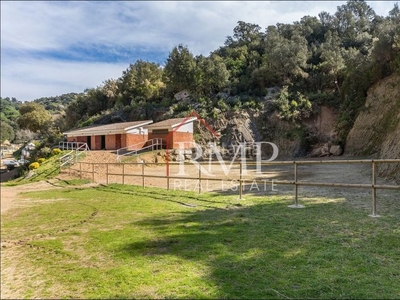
xmin=0 ymin=1 xmax=397 ymax=102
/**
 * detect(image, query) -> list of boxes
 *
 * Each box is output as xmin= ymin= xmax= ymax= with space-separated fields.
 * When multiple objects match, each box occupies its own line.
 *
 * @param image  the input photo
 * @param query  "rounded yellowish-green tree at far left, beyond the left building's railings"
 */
xmin=17 ymin=102 xmax=52 ymax=134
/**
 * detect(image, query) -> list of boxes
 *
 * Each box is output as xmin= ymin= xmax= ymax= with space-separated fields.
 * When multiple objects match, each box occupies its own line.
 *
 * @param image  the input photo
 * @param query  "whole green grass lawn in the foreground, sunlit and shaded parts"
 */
xmin=1 ymin=184 xmax=400 ymax=299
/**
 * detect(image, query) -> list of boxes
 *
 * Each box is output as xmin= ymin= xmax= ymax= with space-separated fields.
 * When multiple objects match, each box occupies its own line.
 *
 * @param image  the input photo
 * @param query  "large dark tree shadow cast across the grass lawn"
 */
xmin=117 ymin=193 xmax=400 ymax=299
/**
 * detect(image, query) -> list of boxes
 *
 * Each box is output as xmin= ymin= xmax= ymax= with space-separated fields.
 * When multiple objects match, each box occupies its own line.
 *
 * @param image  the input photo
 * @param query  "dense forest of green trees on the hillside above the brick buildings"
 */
xmin=1 ymin=0 xmax=400 ymax=145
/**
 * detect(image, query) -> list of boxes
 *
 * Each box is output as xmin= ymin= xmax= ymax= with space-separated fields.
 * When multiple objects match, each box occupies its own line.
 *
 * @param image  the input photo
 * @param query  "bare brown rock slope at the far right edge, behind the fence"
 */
xmin=345 ymin=75 xmax=400 ymax=182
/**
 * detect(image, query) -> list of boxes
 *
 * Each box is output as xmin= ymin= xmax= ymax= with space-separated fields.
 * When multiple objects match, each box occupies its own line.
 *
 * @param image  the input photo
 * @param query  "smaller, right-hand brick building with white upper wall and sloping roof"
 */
xmin=146 ymin=117 xmax=197 ymax=149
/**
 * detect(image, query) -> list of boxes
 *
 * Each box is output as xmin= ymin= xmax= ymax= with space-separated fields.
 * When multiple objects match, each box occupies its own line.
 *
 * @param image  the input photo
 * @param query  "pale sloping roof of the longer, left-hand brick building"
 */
xmin=63 ymin=120 xmax=153 ymax=136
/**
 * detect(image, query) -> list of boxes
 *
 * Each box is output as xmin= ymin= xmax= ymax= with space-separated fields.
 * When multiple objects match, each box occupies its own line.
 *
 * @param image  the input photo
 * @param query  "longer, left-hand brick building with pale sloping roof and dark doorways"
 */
xmin=63 ymin=120 xmax=153 ymax=150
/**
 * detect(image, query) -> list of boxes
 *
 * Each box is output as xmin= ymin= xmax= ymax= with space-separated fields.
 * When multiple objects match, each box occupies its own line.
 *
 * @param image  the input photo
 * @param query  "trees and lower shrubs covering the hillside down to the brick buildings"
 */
xmin=2 ymin=0 xmax=400 ymax=159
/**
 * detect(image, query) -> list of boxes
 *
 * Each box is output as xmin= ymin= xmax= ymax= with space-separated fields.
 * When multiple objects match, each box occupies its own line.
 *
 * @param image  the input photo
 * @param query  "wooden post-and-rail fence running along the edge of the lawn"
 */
xmin=63 ymin=159 xmax=400 ymax=217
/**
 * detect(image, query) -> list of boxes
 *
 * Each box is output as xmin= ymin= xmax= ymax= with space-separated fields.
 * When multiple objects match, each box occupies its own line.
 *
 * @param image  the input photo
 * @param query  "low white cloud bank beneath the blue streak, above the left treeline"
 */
xmin=1 ymin=59 xmax=126 ymax=101
